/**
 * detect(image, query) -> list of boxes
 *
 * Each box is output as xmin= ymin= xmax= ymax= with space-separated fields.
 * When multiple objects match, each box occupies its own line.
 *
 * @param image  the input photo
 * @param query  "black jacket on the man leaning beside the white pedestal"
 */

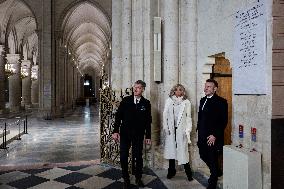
xmin=197 ymin=94 xmax=228 ymax=149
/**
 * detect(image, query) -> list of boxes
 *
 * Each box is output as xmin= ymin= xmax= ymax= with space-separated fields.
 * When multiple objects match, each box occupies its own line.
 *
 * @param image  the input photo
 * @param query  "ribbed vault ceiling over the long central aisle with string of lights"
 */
xmin=62 ymin=2 xmax=111 ymax=74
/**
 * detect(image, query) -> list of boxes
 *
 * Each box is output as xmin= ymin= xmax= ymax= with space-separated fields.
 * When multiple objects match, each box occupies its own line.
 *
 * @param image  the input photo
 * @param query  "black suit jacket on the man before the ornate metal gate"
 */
xmin=113 ymin=95 xmax=152 ymax=139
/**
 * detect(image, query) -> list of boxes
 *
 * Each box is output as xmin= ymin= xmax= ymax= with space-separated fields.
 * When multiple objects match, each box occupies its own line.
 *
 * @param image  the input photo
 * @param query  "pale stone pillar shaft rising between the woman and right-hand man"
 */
xmin=180 ymin=0 xmax=197 ymax=167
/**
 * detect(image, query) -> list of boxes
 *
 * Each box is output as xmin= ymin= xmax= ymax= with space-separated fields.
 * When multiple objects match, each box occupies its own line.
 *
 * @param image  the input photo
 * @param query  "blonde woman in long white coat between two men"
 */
xmin=163 ymin=84 xmax=193 ymax=181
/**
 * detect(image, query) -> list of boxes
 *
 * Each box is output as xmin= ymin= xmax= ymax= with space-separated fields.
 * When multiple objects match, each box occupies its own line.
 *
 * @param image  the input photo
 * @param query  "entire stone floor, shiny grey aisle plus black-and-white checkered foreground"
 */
xmin=0 ymin=107 xmax=209 ymax=189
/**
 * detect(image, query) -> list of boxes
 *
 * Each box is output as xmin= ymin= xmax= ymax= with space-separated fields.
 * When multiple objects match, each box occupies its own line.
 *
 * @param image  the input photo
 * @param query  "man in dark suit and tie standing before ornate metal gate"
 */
xmin=112 ymin=80 xmax=152 ymax=189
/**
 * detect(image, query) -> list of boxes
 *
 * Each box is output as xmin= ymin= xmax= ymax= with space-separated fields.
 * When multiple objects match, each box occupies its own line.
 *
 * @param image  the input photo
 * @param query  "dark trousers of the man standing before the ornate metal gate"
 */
xmin=120 ymin=136 xmax=143 ymax=181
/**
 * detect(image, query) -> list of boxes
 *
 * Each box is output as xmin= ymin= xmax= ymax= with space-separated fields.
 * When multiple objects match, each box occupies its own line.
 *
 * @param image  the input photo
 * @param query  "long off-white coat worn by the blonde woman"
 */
xmin=163 ymin=98 xmax=192 ymax=165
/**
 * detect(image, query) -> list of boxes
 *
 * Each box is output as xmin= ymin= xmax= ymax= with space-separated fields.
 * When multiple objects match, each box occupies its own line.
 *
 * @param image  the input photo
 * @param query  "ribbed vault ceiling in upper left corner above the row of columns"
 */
xmin=0 ymin=0 xmax=38 ymax=59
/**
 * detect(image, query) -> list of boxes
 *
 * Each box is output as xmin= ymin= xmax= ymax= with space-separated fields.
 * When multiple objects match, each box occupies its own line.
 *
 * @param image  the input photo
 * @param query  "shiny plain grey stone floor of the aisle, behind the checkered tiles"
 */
xmin=0 ymin=107 xmax=100 ymax=165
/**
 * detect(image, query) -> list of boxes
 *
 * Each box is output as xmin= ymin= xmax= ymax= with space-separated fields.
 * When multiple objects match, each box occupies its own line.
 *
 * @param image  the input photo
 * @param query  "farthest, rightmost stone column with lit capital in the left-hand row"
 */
xmin=31 ymin=65 xmax=39 ymax=107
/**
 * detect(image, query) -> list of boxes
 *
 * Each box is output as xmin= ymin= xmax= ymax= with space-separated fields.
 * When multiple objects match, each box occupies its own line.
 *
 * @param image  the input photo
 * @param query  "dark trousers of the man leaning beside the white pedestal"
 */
xmin=198 ymin=143 xmax=218 ymax=188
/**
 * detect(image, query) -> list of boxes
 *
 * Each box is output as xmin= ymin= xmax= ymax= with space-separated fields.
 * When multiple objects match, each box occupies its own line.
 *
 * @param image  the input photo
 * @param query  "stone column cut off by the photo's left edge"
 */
xmin=0 ymin=45 xmax=5 ymax=112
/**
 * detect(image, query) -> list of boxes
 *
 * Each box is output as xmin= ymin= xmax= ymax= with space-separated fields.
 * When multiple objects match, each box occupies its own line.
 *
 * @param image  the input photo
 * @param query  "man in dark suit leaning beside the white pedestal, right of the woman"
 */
xmin=197 ymin=79 xmax=228 ymax=189
